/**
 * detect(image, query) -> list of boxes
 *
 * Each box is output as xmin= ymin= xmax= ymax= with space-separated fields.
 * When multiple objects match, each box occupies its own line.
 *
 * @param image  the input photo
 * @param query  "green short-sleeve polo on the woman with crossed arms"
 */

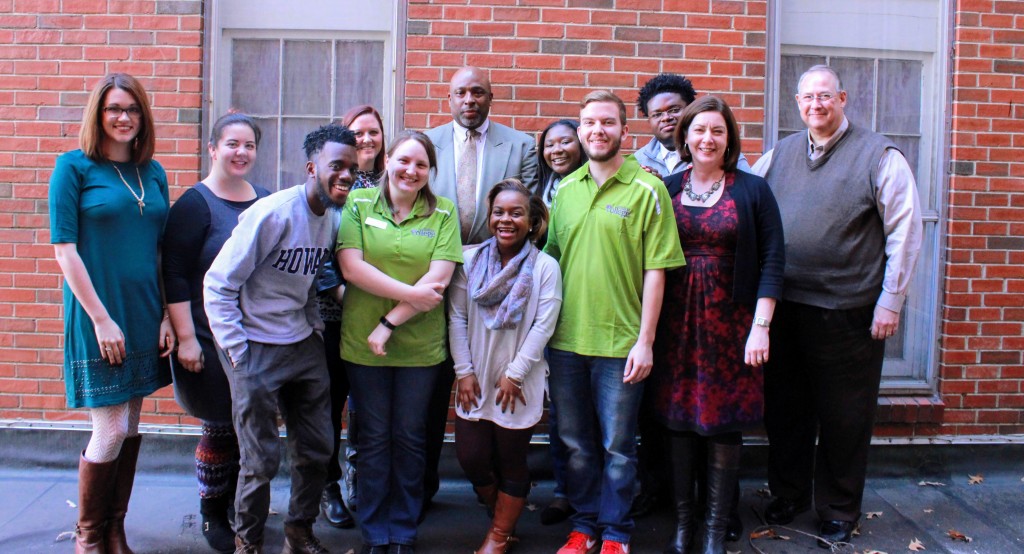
xmin=338 ymin=187 xmax=462 ymax=367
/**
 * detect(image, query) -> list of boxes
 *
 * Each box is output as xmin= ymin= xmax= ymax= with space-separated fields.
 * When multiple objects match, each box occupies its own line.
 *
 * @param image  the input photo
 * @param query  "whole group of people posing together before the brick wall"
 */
xmin=49 ymin=60 xmax=922 ymax=554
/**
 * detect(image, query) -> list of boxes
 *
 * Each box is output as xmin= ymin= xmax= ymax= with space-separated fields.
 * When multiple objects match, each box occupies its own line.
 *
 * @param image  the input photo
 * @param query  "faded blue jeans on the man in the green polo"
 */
xmin=548 ymin=348 xmax=643 ymax=543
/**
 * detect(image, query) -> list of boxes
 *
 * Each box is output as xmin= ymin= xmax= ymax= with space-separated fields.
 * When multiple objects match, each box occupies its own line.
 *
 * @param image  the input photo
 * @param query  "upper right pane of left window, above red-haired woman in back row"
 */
xmin=335 ymin=41 xmax=384 ymax=116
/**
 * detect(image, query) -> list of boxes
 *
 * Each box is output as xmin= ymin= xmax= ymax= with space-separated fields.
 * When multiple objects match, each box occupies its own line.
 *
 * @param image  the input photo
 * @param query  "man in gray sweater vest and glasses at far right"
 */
xmin=754 ymin=66 xmax=922 ymax=548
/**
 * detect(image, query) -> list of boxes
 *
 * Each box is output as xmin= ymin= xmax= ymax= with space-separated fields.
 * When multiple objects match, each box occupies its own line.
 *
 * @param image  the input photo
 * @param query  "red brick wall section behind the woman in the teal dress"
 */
xmin=0 ymin=0 xmax=203 ymax=423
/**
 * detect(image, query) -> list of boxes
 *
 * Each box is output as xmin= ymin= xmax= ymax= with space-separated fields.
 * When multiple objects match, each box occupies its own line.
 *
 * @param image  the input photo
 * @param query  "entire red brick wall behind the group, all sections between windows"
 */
xmin=0 ymin=0 xmax=1024 ymax=436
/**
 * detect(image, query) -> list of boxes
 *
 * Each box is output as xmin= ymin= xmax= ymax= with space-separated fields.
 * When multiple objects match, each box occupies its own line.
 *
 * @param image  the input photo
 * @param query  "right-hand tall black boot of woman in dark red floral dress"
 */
xmin=701 ymin=442 xmax=741 ymax=554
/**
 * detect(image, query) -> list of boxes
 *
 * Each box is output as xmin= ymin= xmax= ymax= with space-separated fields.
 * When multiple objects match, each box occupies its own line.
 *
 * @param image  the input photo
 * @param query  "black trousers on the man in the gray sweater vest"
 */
xmin=765 ymin=301 xmax=885 ymax=521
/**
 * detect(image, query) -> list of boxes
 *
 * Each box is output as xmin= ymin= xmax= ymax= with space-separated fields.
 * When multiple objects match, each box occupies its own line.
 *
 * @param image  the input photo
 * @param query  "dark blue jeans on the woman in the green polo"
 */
xmin=345 ymin=361 xmax=439 ymax=546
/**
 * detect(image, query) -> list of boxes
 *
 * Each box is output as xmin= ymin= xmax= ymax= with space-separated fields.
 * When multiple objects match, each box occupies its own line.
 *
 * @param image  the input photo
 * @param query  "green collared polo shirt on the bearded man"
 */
xmin=544 ymin=155 xmax=686 ymax=357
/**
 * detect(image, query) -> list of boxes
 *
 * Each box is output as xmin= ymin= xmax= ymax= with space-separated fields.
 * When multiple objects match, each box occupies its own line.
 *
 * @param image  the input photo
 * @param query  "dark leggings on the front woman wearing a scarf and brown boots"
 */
xmin=455 ymin=417 xmax=534 ymax=498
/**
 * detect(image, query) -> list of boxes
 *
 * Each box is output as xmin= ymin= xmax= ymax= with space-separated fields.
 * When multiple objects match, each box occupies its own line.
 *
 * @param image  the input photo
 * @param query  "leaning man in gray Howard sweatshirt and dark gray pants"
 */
xmin=203 ymin=125 xmax=358 ymax=554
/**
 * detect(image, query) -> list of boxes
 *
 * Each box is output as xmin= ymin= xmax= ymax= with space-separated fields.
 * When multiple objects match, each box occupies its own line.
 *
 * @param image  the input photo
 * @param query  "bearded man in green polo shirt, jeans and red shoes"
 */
xmin=545 ymin=90 xmax=685 ymax=554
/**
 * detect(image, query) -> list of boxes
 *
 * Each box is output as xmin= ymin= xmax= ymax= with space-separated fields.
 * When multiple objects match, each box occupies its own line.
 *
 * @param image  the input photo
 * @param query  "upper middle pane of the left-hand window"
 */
xmin=282 ymin=40 xmax=331 ymax=117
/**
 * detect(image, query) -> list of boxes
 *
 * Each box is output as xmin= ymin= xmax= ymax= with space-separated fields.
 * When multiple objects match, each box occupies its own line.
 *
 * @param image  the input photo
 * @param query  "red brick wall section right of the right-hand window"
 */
xmin=940 ymin=0 xmax=1024 ymax=434
